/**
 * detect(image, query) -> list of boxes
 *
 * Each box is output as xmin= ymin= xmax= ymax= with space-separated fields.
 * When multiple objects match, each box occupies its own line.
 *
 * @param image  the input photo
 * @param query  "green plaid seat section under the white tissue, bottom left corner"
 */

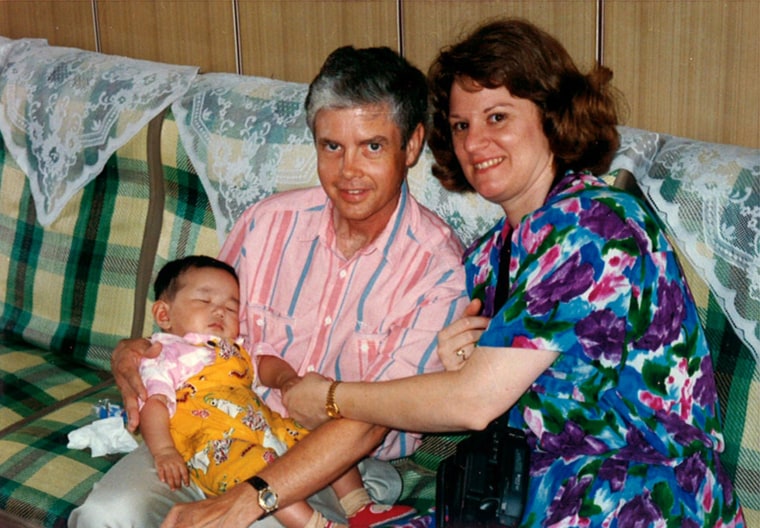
xmin=0 ymin=387 xmax=120 ymax=528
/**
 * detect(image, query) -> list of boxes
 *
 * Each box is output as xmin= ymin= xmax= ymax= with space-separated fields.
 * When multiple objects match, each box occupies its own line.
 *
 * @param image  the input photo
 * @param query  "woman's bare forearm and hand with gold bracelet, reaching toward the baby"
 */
xmin=285 ymin=344 xmax=557 ymax=432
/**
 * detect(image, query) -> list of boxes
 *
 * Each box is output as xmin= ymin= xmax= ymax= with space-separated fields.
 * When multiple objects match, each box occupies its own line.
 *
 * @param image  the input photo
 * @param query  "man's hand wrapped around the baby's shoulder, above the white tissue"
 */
xmin=111 ymin=338 xmax=161 ymax=432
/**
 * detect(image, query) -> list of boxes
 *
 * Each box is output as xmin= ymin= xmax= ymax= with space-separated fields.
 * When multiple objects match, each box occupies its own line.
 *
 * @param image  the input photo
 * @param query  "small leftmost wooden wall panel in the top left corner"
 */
xmin=0 ymin=0 xmax=96 ymax=51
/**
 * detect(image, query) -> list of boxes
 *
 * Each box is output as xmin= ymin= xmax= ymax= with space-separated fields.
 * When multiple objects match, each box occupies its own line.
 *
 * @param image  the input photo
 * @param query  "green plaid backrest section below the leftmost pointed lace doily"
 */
xmin=0 ymin=130 xmax=153 ymax=369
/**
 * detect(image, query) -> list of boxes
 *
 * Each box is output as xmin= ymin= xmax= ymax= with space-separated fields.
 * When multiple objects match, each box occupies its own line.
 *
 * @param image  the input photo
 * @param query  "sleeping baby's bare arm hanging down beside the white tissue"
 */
xmin=140 ymin=395 xmax=190 ymax=490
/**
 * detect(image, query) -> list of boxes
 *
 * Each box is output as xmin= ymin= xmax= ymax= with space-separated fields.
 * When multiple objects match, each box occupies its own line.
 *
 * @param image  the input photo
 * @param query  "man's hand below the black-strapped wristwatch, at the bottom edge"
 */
xmin=161 ymin=482 xmax=264 ymax=528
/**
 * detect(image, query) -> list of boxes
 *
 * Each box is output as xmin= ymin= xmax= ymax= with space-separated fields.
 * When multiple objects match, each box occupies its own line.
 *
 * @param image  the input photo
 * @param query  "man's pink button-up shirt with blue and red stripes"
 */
xmin=220 ymin=185 xmax=468 ymax=460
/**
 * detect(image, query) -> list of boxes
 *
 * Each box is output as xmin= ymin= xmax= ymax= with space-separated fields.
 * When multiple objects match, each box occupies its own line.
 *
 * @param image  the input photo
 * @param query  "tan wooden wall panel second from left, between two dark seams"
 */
xmin=97 ymin=0 xmax=236 ymax=73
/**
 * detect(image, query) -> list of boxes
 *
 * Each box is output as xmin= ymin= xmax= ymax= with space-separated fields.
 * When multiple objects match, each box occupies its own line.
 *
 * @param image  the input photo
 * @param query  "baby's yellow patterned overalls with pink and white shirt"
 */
xmin=140 ymin=334 xmax=308 ymax=495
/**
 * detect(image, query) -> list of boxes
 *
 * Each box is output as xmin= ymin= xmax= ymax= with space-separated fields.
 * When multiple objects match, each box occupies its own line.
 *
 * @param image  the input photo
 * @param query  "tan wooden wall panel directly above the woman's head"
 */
xmin=402 ymin=0 xmax=597 ymax=78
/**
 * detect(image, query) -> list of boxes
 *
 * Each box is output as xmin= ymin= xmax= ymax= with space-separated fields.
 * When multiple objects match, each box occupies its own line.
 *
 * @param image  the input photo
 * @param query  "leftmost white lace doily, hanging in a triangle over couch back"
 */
xmin=0 ymin=39 xmax=197 ymax=225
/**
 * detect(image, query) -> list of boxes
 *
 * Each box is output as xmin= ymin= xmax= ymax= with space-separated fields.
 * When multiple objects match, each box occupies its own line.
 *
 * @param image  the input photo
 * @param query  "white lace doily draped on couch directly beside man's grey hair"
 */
xmin=172 ymin=73 xmax=319 ymax=241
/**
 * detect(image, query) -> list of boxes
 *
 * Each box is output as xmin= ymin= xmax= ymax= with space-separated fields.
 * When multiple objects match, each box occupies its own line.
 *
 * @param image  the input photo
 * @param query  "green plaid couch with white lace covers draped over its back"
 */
xmin=0 ymin=38 xmax=760 ymax=527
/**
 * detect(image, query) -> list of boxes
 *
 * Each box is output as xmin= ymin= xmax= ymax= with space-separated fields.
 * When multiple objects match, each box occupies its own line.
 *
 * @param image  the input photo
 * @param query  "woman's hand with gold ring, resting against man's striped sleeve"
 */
xmin=438 ymin=299 xmax=490 ymax=370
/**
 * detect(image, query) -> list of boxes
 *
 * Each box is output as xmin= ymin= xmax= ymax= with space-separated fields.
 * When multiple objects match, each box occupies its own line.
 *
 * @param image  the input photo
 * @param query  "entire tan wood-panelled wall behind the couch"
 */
xmin=0 ymin=0 xmax=760 ymax=147
